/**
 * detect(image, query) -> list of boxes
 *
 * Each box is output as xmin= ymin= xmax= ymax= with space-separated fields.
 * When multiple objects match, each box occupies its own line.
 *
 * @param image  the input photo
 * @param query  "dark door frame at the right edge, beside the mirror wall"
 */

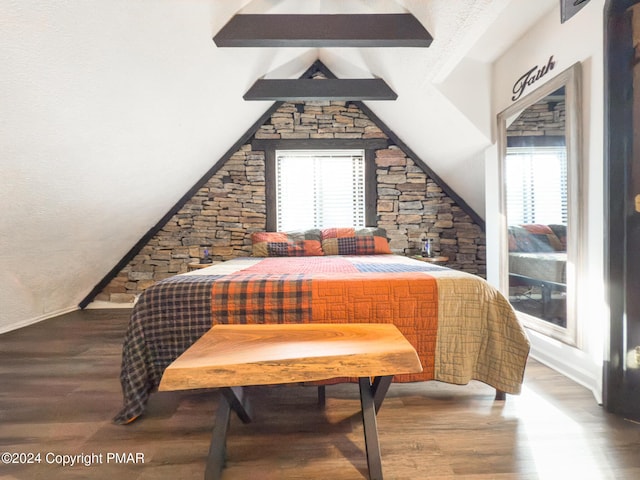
xmin=603 ymin=0 xmax=640 ymax=420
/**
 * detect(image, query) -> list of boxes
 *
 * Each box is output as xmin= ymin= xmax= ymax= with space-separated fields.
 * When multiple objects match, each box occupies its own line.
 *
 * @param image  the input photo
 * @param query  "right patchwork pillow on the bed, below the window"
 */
xmin=321 ymin=227 xmax=391 ymax=255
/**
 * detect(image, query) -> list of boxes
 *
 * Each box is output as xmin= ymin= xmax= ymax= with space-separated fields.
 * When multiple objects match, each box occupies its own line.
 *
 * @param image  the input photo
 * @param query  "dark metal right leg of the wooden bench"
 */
xmin=358 ymin=376 xmax=393 ymax=480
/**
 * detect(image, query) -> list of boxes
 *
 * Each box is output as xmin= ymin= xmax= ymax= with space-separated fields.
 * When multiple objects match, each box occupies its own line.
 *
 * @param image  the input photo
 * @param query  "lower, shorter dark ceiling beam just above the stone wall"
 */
xmin=243 ymin=78 xmax=398 ymax=101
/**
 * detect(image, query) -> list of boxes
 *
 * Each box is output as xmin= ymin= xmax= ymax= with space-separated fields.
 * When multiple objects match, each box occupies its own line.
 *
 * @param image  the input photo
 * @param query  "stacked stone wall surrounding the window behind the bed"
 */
xmin=96 ymin=102 xmax=486 ymax=302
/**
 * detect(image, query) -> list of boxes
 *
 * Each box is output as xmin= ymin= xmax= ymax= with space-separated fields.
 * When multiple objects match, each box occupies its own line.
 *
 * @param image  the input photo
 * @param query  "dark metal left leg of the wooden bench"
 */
xmin=204 ymin=387 xmax=251 ymax=480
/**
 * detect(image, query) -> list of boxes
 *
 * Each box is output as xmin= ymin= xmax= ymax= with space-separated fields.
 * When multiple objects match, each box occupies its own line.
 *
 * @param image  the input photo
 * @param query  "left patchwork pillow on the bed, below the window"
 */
xmin=251 ymin=228 xmax=324 ymax=257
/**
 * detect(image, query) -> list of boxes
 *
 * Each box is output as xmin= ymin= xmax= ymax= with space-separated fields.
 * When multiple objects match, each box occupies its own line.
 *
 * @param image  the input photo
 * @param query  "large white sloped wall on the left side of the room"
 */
xmin=0 ymin=0 xmax=268 ymax=332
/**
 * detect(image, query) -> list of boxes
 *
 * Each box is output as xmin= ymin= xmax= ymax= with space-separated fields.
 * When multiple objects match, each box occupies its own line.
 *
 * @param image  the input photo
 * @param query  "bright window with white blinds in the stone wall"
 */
xmin=276 ymin=150 xmax=365 ymax=231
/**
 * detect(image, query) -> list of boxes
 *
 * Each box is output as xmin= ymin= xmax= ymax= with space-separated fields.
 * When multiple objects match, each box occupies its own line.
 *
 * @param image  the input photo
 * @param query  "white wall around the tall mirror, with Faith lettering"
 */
xmin=485 ymin=0 xmax=608 ymax=401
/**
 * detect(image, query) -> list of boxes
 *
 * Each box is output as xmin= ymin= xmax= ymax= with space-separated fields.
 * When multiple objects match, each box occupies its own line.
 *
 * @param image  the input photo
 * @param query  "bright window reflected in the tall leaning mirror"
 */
xmin=505 ymin=146 xmax=567 ymax=225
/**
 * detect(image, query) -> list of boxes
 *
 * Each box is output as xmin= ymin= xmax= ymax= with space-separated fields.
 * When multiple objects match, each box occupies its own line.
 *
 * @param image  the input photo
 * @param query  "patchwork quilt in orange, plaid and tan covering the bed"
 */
xmin=113 ymin=249 xmax=529 ymax=424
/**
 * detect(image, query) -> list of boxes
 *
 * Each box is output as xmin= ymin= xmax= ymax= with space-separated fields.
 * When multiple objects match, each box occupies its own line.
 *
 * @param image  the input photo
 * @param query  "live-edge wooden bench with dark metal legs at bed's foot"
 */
xmin=159 ymin=324 xmax=422 ymax=480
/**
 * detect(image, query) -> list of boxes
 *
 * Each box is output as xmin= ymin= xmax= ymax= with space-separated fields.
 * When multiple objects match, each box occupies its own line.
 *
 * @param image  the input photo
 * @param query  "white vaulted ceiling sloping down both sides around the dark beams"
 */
xmin=0 ymin=0 xmax=559 ymax=331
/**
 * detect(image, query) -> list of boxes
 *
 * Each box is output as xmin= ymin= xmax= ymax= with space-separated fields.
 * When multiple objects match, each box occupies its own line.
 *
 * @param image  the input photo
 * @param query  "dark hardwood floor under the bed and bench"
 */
xmin=0 ymin=309 xmax=640 ymax=480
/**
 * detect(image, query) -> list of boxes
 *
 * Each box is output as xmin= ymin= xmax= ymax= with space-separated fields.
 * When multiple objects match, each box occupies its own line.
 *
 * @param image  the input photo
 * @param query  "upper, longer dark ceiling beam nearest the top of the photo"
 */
xmin=213 ymin=13 xmax=433 ymax=47
